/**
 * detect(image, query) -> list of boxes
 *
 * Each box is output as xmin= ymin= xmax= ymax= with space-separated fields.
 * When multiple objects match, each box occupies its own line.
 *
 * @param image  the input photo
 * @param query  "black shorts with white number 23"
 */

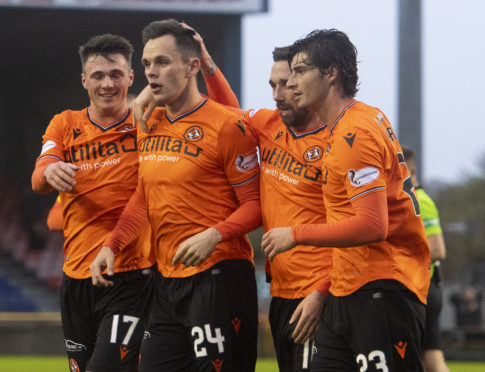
xmin=311 ymin=280 xmax=425 ymax=372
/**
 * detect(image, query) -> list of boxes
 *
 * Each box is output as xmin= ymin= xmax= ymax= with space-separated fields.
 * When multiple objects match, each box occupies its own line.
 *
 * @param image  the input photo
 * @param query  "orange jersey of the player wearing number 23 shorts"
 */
xmin=323 ymin=101 xmax=430 ymax=303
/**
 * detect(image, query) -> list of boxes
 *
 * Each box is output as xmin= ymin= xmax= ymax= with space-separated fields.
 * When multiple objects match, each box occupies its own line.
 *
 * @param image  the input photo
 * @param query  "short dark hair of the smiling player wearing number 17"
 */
xmin=79 ymin=34 xmax=133 ymax=71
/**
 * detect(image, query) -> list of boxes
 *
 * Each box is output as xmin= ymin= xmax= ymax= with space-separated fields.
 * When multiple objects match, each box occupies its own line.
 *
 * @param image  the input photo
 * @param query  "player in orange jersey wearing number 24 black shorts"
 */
xmin=88 ymin=20 xmax=261 ymax=372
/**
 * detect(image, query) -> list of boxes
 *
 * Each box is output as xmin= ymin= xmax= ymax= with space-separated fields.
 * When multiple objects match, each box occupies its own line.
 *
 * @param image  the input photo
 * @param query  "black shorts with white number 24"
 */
xmin=140 ymin=260 xmax=258 ymax=372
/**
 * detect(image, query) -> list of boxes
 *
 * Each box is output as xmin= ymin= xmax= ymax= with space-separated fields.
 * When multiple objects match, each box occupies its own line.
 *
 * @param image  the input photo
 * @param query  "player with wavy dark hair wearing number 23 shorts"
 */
xmin=262 ymin=29 xmax=430 ymax=371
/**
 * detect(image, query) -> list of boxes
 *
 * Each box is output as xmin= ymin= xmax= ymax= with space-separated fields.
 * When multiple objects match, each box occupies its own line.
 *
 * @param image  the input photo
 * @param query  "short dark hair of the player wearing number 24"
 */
xmin=142 ymin=19 xmax=201 ymax=62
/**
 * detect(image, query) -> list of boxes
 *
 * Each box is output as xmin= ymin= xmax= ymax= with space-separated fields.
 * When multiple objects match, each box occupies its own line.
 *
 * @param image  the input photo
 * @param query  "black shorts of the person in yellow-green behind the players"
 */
xmin=424 ymin=276 xmax=443 ymax=350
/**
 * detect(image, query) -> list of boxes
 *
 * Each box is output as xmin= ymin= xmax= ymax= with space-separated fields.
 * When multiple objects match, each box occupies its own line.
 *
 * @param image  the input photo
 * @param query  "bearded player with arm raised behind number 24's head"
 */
xmin=135 ymin=34 xmax=332 ymax=372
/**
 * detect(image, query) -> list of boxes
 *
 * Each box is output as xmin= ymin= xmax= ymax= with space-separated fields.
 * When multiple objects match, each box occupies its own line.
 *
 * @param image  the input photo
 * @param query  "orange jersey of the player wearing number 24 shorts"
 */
xmin=138 ymin=99 xmax=260 ymax=277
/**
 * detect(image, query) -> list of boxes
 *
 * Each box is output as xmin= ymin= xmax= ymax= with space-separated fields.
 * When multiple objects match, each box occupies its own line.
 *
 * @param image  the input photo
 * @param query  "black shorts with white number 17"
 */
xmin=60 ymin=268 xmax=157 ymax=372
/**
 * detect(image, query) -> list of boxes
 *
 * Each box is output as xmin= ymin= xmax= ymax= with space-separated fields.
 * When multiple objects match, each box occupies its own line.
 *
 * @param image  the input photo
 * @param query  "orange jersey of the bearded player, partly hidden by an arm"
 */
xmin=245 ymin=109 xmax=332 ymax=299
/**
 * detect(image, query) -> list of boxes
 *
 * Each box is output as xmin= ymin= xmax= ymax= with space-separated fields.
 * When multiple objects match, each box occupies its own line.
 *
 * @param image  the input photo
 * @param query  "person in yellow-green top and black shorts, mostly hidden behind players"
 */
xmin=402 ymin=146 xmax=449 ymax=372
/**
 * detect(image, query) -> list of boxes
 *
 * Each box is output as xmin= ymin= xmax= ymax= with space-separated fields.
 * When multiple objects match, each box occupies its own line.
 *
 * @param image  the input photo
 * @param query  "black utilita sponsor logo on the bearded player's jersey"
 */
xmin=261 ymin=147 xmax=322 ymax=181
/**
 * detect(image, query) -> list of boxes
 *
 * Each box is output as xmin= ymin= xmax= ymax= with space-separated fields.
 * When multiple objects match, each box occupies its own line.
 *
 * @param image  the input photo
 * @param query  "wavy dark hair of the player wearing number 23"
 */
xmin=288 ymin=28 xmax=359 ymax=97
